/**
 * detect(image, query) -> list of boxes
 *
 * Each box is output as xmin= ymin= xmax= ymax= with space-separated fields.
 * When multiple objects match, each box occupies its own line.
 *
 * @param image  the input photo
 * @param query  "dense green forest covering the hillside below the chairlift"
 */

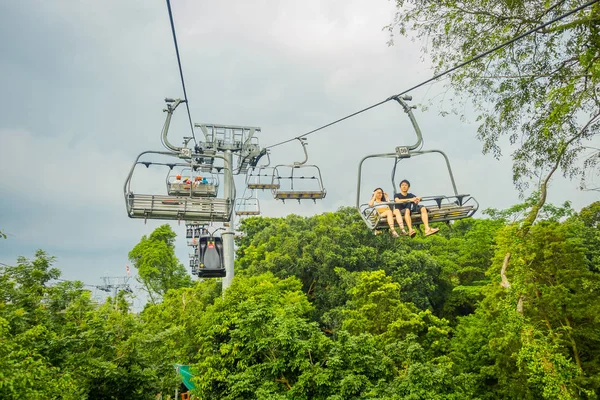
xmin=0 ymin=199 xmax=600 ymax=400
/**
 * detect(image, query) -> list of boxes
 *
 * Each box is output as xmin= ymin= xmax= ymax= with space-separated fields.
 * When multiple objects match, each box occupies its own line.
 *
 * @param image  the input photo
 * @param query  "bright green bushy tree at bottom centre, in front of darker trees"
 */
xmin=190 ymin=274 xmax=329 ymax=399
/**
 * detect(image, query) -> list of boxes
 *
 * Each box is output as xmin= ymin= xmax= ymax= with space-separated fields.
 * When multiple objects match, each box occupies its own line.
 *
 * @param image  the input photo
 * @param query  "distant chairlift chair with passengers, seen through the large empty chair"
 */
xmin=167 ymin=168 xmax=219 ymax=197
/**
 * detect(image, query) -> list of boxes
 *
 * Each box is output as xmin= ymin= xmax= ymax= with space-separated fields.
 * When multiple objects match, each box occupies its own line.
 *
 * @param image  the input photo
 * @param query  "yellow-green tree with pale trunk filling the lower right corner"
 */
xmin=453 ymin=218 xmax=600 ymax=399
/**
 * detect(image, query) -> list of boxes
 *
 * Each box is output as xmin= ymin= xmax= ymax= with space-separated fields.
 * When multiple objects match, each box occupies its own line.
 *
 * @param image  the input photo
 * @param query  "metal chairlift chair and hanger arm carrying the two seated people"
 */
xmin=356 ymin=96 xmax=479 ymax=231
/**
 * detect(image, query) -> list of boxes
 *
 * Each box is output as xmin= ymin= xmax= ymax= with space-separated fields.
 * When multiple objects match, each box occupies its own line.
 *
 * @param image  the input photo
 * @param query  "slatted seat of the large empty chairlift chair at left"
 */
xmin=126 ymin=193 xmax=231 ymax=222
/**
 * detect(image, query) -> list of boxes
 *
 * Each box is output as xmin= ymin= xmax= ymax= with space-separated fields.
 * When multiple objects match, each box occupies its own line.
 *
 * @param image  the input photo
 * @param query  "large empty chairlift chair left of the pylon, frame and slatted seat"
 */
xmin=123 ymin=151 xmax=234 ymax=222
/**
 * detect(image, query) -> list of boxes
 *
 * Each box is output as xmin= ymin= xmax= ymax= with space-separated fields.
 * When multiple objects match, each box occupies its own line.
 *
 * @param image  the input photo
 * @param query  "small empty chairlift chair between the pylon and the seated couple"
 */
xmin=271 ymin=165 xmax=327 ymax=203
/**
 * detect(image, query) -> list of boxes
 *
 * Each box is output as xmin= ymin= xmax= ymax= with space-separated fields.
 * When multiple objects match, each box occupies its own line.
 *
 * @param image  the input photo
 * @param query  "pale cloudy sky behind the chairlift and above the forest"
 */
xmin=0 ymin=0 xmax=598 ymax=306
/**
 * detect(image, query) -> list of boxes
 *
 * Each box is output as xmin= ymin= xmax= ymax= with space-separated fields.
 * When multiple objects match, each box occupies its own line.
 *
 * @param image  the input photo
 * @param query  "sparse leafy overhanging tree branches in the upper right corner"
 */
xmin=388 ymin=0 xmax=600 ymax=226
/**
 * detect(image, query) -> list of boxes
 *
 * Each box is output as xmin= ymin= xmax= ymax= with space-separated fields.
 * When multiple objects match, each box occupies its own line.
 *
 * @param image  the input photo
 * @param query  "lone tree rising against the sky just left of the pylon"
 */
xmin=129 ymin=224 xmax=192 ymax=303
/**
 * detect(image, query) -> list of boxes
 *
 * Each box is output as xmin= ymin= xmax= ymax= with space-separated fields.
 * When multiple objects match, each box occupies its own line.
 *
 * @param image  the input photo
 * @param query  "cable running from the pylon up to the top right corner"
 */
xmin=265 ymin=0 xmax=600 ymax=149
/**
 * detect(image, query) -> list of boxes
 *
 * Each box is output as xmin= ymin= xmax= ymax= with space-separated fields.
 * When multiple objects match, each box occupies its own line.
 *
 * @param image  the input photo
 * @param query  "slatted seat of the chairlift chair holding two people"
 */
xmin=360 ymin=194 xmax=479 ymax=230
